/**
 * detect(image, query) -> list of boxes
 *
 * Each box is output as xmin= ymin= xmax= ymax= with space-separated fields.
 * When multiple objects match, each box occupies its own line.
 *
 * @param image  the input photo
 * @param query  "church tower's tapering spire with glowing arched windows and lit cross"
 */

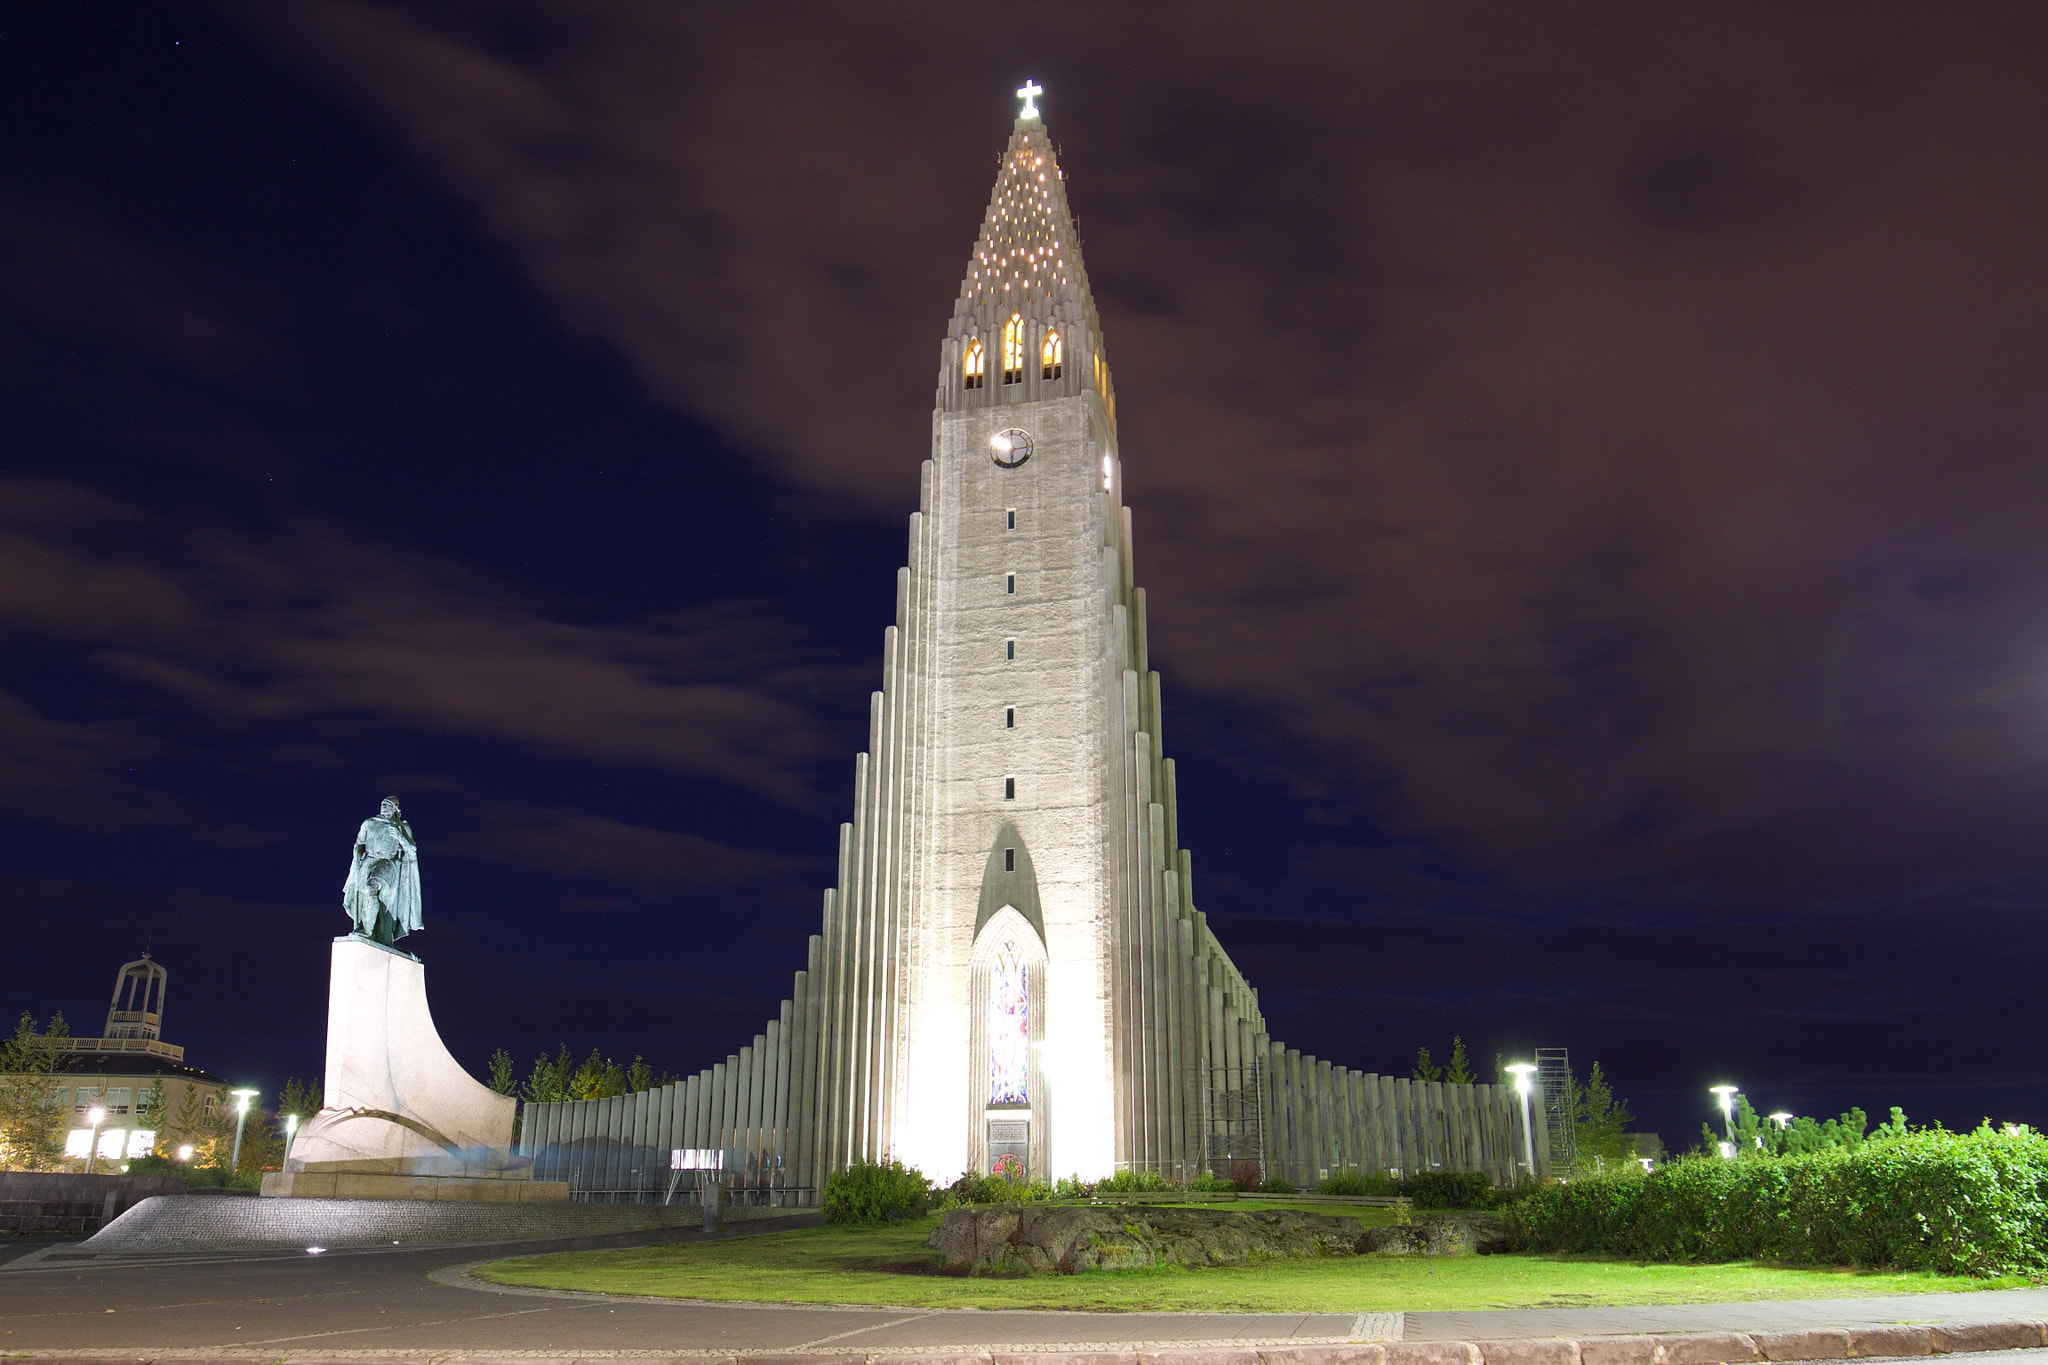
xmin=938 ymin=80 xmax=1114 ymax=424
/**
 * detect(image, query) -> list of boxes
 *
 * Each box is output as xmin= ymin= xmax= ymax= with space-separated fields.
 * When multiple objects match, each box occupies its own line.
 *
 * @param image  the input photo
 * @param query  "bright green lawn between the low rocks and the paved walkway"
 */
xmin=475 ymin=1201 xmax=2023 ymax=1312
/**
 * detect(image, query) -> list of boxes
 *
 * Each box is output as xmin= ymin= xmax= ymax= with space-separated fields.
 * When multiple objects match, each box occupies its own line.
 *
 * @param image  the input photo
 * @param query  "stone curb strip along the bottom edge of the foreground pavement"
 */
xmin=0 ymin=1322 xmax=2048 ymax=1365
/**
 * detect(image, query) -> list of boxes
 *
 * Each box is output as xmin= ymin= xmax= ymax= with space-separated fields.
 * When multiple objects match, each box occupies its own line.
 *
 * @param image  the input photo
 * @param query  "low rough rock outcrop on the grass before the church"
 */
xmin=930 ymin=1203 xmax=1505 ymax=1273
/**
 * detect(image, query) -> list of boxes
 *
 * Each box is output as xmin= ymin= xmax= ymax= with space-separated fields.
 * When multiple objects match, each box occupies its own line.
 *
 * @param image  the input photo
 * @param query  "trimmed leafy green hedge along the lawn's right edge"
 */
xmin=1509 ymin=1126 xmax=2048 ymax=1277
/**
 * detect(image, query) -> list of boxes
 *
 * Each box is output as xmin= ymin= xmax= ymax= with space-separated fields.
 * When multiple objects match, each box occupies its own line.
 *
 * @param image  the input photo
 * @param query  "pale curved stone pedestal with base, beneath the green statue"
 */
xmin=264 ymin=935 xmax=569 ymax=1203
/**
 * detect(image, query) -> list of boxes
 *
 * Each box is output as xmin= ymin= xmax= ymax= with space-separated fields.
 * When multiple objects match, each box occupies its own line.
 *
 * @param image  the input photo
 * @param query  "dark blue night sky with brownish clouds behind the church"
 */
xmin=0 ymin=0 xmax=2048 ymax=1146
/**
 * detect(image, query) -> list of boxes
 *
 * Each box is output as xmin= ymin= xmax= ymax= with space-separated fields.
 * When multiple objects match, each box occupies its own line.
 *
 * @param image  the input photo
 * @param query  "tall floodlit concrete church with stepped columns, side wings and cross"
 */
xmin=520 ymin=84 xmax=1542 ymax=1197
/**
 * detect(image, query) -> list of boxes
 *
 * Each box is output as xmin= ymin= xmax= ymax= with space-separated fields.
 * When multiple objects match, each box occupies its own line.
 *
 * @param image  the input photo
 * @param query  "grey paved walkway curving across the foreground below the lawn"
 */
xmin=0 ymin=1244 xmax=2048 ymax=1365
